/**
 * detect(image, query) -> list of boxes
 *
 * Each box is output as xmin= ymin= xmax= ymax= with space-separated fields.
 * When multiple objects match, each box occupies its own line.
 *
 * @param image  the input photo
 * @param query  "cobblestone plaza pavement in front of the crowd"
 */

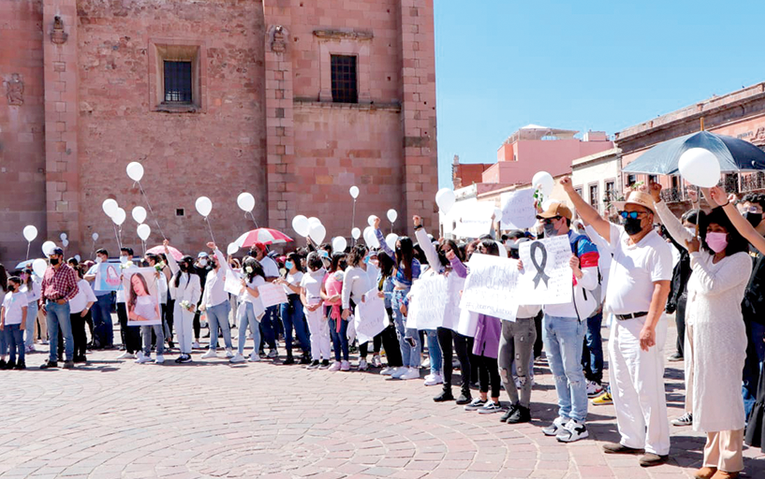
xmin=0 ymin=318 xmax=765 ymax=479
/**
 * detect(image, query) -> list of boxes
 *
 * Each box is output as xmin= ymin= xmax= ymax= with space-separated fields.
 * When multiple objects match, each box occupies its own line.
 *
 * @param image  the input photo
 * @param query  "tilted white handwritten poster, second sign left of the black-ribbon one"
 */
xmin=406 ymin=274 xmax=446 ymax=329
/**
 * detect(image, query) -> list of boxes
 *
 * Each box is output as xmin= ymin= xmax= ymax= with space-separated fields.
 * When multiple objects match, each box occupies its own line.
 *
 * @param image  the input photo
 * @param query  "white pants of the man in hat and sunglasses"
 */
xmin=608 ymin=316 xmax=669 ymax=456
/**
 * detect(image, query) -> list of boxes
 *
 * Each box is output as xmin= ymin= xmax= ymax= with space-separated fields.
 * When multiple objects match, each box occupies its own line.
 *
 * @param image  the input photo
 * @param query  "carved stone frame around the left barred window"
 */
xmin=148 ymin=38 xmax=207 ymax=113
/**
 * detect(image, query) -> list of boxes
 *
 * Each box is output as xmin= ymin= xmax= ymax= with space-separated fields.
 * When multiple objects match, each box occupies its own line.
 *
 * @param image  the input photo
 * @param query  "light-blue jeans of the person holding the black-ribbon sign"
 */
xmin=542 ymin=314 xmax=587 ymax=422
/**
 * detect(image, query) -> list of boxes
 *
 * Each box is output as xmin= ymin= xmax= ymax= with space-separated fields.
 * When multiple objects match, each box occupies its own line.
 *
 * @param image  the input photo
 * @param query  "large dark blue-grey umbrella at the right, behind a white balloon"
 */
xmin=622 ymin=131 xmax=765 ymax=175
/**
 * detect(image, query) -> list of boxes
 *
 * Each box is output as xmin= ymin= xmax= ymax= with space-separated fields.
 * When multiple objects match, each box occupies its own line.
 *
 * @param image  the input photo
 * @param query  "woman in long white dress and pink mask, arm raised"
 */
xmin=651 ymin=184 xmax=752 ymax=479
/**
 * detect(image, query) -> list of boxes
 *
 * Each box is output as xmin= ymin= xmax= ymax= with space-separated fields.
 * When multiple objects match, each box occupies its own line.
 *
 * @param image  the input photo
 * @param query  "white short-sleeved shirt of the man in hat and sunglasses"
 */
xmin=606 ymin=224 xmax=672 ymax=314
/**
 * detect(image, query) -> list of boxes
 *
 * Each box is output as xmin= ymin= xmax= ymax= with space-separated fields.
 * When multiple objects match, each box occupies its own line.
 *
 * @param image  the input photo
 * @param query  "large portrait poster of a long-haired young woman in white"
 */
xmin=122 ymin=268 xmax=162 ymax=326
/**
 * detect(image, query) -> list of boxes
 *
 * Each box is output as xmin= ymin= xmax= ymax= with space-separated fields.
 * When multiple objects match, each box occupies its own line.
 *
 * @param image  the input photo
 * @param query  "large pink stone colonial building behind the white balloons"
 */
xmin=0 ymin=0 xmax=437 ymax=263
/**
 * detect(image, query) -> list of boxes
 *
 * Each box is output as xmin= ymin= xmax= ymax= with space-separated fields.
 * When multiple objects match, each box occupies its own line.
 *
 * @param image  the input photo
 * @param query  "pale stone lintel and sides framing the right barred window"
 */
xmin=313 ymin=30 xmax=374 ymax=104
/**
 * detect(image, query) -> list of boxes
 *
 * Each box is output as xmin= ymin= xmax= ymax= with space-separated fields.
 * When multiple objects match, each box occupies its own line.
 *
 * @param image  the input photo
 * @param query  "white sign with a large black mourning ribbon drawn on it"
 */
xmin=518 ymin=235 xmax=573 ymax=304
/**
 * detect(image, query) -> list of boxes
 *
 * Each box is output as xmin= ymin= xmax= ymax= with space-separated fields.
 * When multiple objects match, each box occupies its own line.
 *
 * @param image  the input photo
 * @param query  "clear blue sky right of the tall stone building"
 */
xmin=434 ymin=0 xmax=765 ymax=186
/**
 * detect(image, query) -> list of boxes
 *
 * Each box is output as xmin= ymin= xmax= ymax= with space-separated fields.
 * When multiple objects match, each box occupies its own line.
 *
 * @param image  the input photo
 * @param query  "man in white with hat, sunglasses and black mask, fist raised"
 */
xmin=561 ymin=178 xmax=672 ymax=467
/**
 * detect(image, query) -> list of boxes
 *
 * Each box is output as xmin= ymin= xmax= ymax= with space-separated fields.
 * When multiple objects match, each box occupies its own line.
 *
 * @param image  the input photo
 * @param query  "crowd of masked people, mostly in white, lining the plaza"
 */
xmin=0 ymin=178 xmax=765 ymax=479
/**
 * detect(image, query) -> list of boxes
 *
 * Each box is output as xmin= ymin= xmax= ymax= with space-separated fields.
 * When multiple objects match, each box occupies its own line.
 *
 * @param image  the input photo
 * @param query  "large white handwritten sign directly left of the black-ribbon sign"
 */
xmin=460 ymin=254 xmax=520 ymax=321
